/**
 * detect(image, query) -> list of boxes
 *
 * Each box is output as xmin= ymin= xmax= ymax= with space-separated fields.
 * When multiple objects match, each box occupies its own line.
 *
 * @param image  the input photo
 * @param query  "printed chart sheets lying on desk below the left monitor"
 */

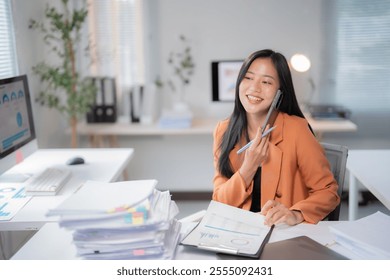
xmin=0 ymin=184 xmax=31 ymax=221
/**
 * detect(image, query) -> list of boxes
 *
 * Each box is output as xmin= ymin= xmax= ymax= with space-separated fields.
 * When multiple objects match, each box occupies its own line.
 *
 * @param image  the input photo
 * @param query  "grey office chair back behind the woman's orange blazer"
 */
xmin=321 ymin=143 xmax=348 ymax=221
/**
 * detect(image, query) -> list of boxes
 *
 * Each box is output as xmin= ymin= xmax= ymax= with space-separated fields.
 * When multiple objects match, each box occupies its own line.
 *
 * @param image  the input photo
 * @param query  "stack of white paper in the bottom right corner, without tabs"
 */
xmin=330 ymin=212 xmax=390 ymax=260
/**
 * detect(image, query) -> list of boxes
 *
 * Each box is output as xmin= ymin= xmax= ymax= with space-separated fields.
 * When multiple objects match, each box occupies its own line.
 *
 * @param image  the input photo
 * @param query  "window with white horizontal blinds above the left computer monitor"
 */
xmin=0 ymin=0 xmax=18 ymax=78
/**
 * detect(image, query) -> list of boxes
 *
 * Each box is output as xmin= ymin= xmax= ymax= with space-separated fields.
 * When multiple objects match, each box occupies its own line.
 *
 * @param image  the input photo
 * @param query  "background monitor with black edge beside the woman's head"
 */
xmin=211 ymin=60 xmax=244 ymax=101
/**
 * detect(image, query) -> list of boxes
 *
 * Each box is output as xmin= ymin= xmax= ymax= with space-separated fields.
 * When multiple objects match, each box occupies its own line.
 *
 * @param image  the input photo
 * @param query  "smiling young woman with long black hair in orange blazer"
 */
xmin=213 ymin=50 xmax=340 ymax=225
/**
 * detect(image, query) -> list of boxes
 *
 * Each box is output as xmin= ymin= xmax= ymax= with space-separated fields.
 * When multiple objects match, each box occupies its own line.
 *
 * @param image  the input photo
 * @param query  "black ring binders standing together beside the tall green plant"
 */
xmin=87 ymin=77 xmax=117 ymax=123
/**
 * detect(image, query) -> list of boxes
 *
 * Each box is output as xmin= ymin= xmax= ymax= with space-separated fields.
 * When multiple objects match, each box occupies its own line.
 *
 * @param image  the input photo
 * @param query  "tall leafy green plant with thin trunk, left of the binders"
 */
xmin=29 ymin=0 xmax=96 ymax=148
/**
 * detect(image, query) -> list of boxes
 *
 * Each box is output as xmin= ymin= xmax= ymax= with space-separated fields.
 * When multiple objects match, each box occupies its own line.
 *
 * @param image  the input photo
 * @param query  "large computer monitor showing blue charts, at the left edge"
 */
xmin=0 ymin=75 xmax=38 ymax=182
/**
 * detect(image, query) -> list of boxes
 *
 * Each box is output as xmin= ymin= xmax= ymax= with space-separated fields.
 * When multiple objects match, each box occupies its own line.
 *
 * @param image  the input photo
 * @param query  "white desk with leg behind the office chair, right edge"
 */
xmin=347 ymin=150 xmax=390 ymax=221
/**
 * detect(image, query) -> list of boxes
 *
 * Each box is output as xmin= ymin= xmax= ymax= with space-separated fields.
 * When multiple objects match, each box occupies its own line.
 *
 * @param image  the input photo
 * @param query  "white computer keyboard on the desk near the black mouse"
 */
xmin=24 ymin=168 xmax=71 ymax=195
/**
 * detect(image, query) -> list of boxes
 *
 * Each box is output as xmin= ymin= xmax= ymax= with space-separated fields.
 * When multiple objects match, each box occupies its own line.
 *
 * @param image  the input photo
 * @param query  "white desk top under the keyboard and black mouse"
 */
xmin=0 ymin=148 xmax=133 ymax=231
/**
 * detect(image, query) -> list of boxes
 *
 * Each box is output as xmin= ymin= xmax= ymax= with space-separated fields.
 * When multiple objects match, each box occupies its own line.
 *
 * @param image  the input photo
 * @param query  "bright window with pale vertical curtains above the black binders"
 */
xmin=88 ymin=0 xmax=145 ymax=106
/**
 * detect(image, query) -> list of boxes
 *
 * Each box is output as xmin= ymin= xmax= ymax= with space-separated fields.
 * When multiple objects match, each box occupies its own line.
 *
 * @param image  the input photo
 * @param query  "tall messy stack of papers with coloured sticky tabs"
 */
xmin=48 ymin=180 xmax=180 ymax=259
